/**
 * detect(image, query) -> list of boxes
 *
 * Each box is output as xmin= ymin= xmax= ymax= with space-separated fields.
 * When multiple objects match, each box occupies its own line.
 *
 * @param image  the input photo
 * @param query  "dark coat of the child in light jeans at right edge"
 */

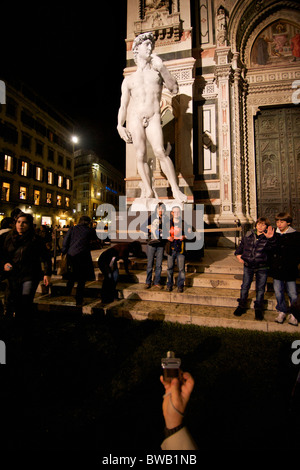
xmin=270 ymin=227 xmax=300 ymax=281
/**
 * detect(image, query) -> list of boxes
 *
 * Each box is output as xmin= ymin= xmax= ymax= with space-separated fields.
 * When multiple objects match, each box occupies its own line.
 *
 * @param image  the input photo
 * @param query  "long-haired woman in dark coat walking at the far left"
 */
xmin=0 ymin=212 xmax=52 ymax=323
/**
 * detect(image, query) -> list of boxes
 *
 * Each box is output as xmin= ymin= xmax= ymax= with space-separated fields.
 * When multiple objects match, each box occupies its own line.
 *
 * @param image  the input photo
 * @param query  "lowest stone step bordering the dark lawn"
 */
xmin=35 ymin=294 xmax=297 ymax=334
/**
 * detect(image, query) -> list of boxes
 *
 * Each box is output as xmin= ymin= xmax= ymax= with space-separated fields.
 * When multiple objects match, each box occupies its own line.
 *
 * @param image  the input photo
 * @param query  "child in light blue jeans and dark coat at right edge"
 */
xmin=271 ymin=212 xmax=300 ymax=326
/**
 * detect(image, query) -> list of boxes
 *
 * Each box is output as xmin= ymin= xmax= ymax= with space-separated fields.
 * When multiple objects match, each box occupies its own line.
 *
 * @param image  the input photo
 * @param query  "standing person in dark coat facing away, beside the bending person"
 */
xmin=62 ymin=216 xmax=97 ymax=306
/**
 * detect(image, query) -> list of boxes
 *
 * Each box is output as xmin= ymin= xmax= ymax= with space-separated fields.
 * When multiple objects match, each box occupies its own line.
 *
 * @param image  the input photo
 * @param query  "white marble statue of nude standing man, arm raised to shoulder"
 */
xmin=117 ymin=32 xmax=187 ymax=202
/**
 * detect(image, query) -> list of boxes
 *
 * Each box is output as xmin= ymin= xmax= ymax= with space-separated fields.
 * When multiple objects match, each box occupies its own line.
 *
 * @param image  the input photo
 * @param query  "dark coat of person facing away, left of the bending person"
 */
xmin=62 ymin=224 xmax=97 ymax=281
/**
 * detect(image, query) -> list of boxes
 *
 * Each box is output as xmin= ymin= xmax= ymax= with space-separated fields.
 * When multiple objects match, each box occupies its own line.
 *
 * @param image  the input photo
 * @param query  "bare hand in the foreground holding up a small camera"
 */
xmin=160 ymin=372 xmax=194 ymax=429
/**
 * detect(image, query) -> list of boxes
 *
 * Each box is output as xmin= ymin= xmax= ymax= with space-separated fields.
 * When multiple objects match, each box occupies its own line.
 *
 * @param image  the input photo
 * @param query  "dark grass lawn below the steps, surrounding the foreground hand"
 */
xmin=0 ymin=315 xmax=299 ymax=451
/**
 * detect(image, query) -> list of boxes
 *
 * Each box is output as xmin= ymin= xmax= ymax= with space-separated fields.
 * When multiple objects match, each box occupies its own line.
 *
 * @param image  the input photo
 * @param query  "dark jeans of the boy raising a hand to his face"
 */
xmin=239 ymin=266 xmax=268 ymax=309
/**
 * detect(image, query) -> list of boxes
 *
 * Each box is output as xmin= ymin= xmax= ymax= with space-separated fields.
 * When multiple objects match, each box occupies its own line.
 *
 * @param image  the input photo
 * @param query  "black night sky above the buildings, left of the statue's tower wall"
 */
xmin=0 ymin=0 xmax=127 ymax=172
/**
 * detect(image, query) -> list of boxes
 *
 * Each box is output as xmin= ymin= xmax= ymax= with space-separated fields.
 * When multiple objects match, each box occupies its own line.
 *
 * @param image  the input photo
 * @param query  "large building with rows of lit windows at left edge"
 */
xmin=0 ymin=83 xmax=74 ymax=227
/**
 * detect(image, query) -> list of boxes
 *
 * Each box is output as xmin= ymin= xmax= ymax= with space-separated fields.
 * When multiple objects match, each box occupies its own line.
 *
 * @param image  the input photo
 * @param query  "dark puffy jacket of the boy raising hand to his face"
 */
xmin=234 ymin=230 xmax=275 ymax=269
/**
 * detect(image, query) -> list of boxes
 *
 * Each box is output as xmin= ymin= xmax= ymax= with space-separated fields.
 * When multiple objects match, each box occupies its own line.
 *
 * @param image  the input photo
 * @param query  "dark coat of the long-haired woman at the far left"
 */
xmin=0 ymin=230 xmax=52 ymax=283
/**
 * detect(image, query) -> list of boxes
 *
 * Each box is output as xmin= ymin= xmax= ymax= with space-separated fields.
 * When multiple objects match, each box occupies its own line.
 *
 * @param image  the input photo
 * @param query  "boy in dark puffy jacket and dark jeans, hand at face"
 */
xmin=234 ymin=217 xmax=275 ymax=320
